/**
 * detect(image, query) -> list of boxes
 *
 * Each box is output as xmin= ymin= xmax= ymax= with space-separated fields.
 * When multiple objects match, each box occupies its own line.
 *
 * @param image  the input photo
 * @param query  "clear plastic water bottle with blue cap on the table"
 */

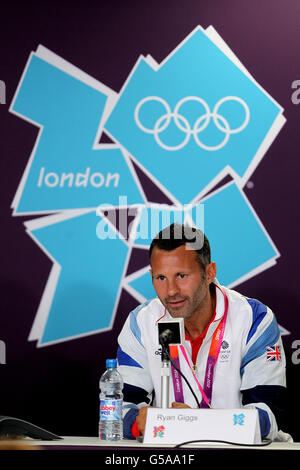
xmin=99 ymin=359 xmax=123 ymax=441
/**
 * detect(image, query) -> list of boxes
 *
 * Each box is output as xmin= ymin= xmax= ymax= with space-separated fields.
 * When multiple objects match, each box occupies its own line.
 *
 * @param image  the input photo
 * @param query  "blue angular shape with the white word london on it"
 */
xmin=12 ymin=56 xmax=144 ymax=214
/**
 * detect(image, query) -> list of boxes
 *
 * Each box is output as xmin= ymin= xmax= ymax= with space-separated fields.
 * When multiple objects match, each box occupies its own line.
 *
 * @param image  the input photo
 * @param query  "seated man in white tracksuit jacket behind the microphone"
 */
xmin=118 ymin=224 xmax=286 ymax=440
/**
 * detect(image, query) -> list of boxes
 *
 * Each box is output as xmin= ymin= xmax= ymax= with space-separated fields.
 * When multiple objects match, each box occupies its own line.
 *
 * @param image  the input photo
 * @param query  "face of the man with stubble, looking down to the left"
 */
xmin=151 ymin=245 xmax=214 ymax=319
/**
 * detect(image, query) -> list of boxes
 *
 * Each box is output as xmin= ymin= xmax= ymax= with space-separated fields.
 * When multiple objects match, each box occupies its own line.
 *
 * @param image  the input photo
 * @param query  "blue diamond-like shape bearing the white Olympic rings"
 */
xmin=105 ymin=29 xmax=281 ymax=204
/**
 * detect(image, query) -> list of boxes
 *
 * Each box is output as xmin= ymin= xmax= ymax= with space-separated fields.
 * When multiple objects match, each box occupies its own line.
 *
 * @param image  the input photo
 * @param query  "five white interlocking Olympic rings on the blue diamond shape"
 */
xmin=134 ymin=96 xmax=250 ymax=151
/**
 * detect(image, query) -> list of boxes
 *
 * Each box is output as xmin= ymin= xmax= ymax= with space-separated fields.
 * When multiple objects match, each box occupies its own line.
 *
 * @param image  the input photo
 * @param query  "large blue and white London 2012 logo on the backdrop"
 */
xmin=10 ymin=27 xmax=287 ymax=346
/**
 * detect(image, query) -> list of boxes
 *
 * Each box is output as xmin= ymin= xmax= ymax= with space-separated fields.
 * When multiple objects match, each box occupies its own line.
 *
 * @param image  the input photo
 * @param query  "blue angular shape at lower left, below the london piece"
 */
xmin=31 ymin=212 xmax=128 ymax=344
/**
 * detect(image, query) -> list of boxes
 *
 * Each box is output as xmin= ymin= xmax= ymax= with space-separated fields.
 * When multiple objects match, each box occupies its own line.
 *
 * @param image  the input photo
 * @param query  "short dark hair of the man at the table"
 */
xmin=149 ymin=223 xmax=211 ymax=272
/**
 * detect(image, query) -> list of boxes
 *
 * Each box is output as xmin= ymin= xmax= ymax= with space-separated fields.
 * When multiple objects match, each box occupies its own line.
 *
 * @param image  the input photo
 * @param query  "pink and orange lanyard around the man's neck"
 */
xmin=169 ymin=286 xmax=228 ymax=408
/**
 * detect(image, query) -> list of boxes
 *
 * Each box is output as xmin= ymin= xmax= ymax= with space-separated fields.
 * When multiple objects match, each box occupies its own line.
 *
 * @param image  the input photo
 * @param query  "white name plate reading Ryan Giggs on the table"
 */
xmin=143 ymin=407 xmax=261 ymax=445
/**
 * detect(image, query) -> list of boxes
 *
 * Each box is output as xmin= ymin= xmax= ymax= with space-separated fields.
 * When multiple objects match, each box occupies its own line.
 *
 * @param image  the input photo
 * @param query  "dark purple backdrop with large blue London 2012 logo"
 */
xmin=0 ymin=0 xmax=300 ymax=440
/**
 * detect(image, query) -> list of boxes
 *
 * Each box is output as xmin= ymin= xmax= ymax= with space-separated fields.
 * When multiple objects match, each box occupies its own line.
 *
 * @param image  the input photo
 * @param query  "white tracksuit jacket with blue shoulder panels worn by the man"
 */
xmin=117 ymin=282 xmax=286 ymax=440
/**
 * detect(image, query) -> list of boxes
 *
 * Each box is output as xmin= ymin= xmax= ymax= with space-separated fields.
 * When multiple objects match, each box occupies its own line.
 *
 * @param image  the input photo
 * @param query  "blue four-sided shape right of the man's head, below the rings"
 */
xmin=201 ymin=183 xmax=278 ymax=286
